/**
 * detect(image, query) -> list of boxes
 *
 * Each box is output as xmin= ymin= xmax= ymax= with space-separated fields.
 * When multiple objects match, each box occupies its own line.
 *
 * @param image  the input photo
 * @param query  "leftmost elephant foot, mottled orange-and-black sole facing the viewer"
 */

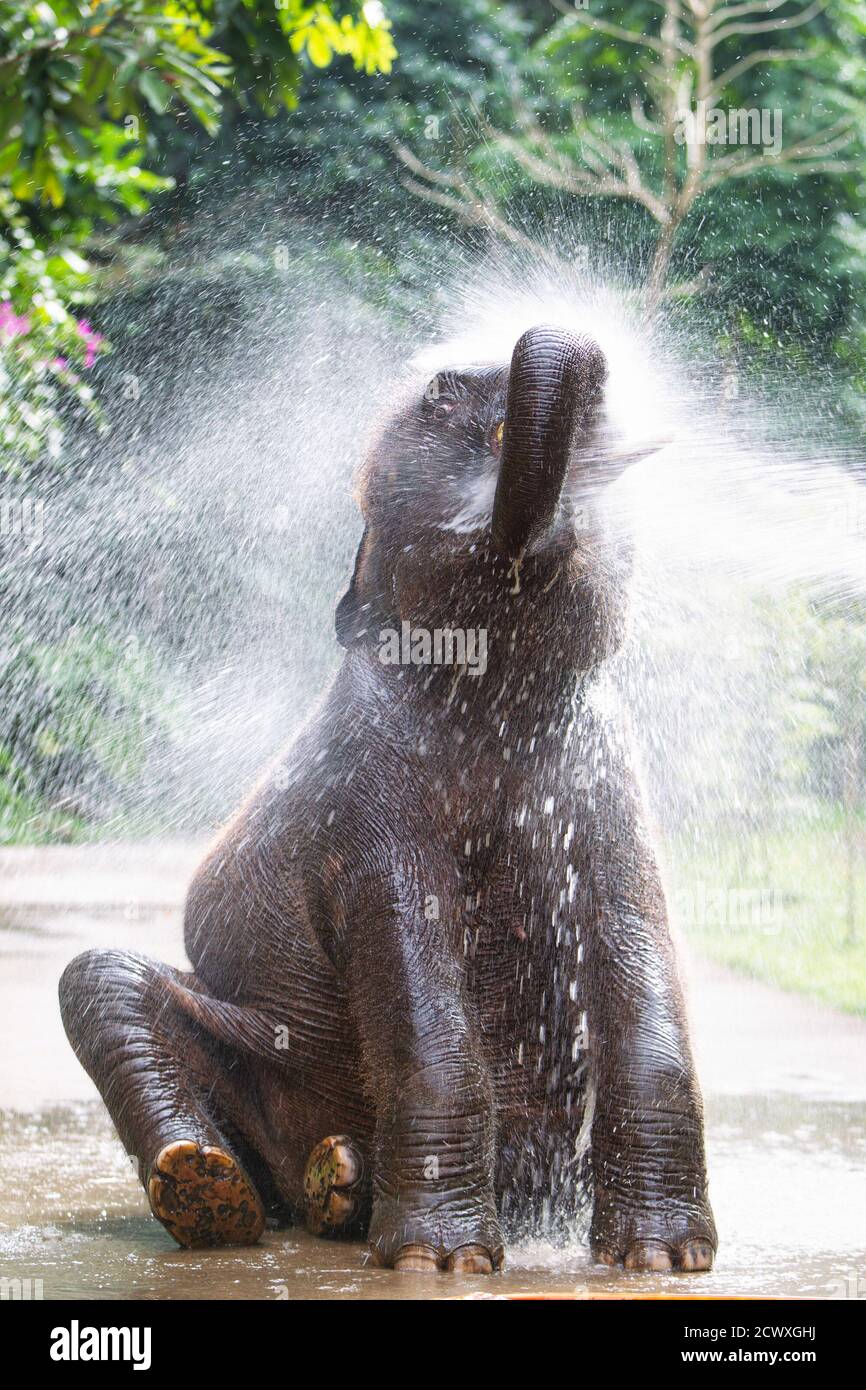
xmin=147 ymin=1138 xmax=264 ymax=1250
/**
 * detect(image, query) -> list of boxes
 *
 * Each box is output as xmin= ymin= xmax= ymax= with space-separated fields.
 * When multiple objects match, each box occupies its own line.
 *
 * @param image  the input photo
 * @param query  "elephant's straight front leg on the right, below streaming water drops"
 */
xmin=587 ymin=811 xmax=717 ymax=1270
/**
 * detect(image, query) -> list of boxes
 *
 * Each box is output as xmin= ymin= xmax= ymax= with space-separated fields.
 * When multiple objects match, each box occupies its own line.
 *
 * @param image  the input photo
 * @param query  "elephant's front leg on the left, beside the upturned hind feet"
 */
xmin=350 ymin=884 xmax=503 ymax=1273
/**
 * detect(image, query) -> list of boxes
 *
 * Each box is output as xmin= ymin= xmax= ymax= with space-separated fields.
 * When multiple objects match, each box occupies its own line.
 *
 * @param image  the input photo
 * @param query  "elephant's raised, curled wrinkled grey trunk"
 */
xmin=492 ymin=324 xmax=606 ymax=559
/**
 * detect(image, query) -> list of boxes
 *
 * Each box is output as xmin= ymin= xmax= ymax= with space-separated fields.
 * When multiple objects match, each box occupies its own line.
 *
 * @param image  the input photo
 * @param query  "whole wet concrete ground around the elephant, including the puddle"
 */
xmin=0 ymin=847 xmax=866 ymax=1300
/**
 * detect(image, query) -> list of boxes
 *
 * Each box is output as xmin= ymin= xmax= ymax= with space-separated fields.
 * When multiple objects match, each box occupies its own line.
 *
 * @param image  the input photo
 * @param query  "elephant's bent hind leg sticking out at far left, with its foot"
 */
xmin=60 ymin=951 xmax=264 ymax=1247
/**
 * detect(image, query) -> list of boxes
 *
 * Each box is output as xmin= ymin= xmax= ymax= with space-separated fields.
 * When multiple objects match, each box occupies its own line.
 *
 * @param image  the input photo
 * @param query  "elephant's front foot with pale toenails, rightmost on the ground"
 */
xmin=589 ymin=1197 xmax=716 ymax=1273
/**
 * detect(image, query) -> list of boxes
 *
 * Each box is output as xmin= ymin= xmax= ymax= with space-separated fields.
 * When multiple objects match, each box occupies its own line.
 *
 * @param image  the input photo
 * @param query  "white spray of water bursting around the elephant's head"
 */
xmin=1 ymin=244 xmax=866 ymax=1000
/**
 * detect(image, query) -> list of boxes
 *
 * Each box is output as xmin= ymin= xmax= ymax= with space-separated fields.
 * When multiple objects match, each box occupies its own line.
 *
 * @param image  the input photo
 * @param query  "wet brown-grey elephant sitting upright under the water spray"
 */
xmin=60 ymin=322 xmax=716 ymax=1275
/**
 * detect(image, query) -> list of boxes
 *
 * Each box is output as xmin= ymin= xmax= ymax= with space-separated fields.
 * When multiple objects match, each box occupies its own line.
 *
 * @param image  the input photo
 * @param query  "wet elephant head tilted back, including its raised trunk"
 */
xmin=336 ymin=324 xmax=653 ymax=669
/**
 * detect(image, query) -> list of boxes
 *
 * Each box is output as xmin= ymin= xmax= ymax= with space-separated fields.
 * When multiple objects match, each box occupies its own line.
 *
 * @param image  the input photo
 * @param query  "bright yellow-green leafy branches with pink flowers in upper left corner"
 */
xmin=0 ymin=0 xmax=395 ymax=474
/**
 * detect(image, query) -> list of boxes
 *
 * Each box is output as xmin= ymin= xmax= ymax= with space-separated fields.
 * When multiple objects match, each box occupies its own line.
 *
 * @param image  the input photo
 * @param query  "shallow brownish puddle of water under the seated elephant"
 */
xmin=0 ymin=1097 xmax=866 ymax=1300
